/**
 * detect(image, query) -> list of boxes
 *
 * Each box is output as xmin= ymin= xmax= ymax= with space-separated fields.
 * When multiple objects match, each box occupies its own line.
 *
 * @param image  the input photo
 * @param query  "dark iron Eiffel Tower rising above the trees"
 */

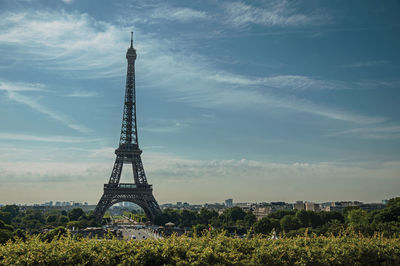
xmin=94 ymin=32 xmax=161 ymax=221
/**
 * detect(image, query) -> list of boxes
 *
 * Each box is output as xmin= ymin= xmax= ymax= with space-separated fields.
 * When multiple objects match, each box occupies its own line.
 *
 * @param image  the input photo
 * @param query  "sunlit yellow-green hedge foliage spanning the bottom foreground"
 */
xmin=0 ymin=233 xmax=400 ymax=265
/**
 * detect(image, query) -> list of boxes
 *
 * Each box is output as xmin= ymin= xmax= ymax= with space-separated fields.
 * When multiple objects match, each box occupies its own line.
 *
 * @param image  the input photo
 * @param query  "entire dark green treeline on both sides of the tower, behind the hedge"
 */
xmin=0 ymin=197 xmax=400 ymax=243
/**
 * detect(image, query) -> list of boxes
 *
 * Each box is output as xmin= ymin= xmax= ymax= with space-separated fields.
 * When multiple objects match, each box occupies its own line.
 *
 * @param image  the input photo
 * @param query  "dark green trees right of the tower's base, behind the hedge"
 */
xmin=155 ymin=197 xmax=400 ymax=237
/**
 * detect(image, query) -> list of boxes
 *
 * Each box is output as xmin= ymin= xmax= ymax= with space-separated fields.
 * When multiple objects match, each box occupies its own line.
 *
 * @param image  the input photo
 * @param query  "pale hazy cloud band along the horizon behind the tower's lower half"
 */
xmin=0 ymin=152 xmax=400 ymax=203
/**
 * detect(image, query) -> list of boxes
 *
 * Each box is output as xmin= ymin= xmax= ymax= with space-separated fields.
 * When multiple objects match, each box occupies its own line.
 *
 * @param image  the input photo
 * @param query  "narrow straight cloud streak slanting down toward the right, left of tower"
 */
xmin=8 ymin=91 xmax=90 ymax=133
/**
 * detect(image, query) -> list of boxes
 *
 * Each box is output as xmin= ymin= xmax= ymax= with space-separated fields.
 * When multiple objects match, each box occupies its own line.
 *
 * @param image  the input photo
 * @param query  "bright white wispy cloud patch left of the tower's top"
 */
xmin=0 ymin=11 xmax=127 ymax=78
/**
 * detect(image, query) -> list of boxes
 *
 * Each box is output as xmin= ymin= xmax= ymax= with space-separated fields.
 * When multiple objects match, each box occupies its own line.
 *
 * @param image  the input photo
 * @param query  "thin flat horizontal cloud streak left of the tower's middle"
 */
xmin=0 ymin=132 xmax=100 ymax=143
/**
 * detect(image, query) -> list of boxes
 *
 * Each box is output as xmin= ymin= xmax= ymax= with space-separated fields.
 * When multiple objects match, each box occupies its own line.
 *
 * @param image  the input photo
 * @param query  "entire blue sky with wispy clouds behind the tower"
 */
xmin=0 ymin=0 xmax=400 ymax=203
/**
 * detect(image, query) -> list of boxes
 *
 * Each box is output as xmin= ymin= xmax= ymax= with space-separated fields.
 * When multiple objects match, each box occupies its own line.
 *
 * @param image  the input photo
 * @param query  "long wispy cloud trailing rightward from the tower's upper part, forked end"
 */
xmin=138 ymin=39 xmax=386 ymax=124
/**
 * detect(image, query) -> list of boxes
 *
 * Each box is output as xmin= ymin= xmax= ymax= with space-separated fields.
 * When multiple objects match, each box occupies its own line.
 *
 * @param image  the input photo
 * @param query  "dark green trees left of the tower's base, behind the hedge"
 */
xmin=0 ymin=205 xmax=98 ymax=243
